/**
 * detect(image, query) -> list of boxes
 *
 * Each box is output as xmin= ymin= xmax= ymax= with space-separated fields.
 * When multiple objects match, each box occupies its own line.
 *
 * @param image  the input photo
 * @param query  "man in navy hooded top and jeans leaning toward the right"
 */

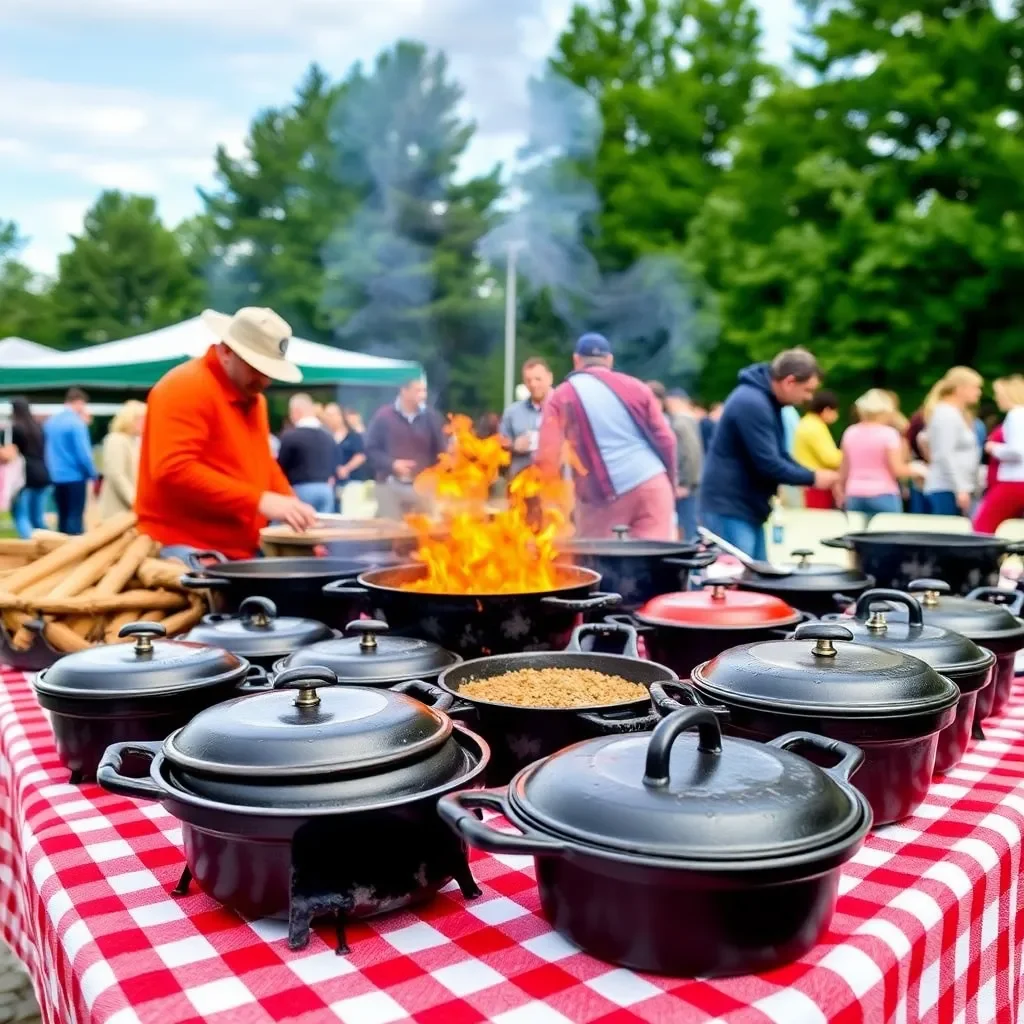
xmin=700 ymin=348 xmax=838 ymax=559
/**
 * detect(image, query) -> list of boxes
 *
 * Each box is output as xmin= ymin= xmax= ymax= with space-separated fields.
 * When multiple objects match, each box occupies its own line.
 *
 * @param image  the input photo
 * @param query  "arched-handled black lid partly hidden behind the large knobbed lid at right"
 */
xmin=841 ymin=589 xmax=995 ymax=676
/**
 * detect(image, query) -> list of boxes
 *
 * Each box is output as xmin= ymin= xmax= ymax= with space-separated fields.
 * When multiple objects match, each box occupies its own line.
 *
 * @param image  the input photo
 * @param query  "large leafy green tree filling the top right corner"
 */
xmin=688 ymin=0 xmax=1024 ymax=399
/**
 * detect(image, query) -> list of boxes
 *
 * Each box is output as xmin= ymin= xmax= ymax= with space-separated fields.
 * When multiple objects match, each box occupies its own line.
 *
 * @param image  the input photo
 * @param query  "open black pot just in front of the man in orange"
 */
xmin=181 ymin=551 xmax=367 ymax=629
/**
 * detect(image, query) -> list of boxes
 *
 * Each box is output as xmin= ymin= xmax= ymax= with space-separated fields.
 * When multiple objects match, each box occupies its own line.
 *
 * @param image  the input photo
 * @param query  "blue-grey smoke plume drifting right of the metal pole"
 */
xmin=479 ymin=71 xmax=714 ymax=381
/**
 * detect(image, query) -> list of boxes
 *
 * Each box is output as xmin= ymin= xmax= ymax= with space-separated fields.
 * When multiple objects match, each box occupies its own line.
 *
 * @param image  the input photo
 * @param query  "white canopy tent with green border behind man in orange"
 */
xmin=0 ymin=316 xmax=423 ymax=394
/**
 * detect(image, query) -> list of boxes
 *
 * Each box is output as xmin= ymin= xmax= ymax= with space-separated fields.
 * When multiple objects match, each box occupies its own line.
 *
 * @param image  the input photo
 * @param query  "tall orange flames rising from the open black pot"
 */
xmin=406 ymin=416 xmax=572 ymax=594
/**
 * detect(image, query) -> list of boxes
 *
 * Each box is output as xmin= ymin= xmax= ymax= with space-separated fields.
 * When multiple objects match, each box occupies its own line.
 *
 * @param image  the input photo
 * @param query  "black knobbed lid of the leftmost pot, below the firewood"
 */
xmin=34 ymin=623 xmax=249 ymax=699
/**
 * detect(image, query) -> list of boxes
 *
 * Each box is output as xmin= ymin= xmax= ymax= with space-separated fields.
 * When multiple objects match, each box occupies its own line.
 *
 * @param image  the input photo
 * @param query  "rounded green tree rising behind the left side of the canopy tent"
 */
xmin=52 ymin=191 xmax=203 ymax=345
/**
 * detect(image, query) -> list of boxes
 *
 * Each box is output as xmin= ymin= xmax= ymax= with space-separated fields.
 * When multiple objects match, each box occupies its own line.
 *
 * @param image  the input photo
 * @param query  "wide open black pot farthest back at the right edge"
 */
xmin=821 ymin=530 xmax=1024 ymax=596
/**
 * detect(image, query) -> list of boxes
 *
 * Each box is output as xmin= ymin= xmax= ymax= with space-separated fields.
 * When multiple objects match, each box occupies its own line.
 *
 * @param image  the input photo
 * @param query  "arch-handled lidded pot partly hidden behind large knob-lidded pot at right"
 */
xmin=842 ymin=590 xmax=995 ymax=772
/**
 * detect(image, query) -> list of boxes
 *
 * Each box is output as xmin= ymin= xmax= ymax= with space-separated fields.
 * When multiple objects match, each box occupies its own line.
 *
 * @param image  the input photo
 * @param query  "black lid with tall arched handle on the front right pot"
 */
xmin=509 ymin=708 xmax=870 ymax=861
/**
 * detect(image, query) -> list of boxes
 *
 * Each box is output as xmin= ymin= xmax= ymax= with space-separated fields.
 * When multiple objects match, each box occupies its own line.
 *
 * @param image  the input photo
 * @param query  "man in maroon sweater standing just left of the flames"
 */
xmin=366 ymin=378 xmax=447 ymax=519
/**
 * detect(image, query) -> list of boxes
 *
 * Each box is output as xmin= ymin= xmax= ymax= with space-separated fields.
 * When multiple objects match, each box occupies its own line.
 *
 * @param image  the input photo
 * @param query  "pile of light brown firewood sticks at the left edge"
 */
xmin=0 ymin=512 xmax=206 ymax=651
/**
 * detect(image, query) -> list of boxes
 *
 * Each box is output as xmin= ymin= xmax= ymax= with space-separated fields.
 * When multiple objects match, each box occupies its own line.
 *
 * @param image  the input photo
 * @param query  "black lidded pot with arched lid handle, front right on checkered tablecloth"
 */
xmin=438 ymin=708 xmax=871 ymax=977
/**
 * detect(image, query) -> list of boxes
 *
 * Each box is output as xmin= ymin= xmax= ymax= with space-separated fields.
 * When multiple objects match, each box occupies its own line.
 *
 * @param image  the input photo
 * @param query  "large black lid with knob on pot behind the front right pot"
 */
xmin=692 ymin=623 xmax=959 ymax=719
